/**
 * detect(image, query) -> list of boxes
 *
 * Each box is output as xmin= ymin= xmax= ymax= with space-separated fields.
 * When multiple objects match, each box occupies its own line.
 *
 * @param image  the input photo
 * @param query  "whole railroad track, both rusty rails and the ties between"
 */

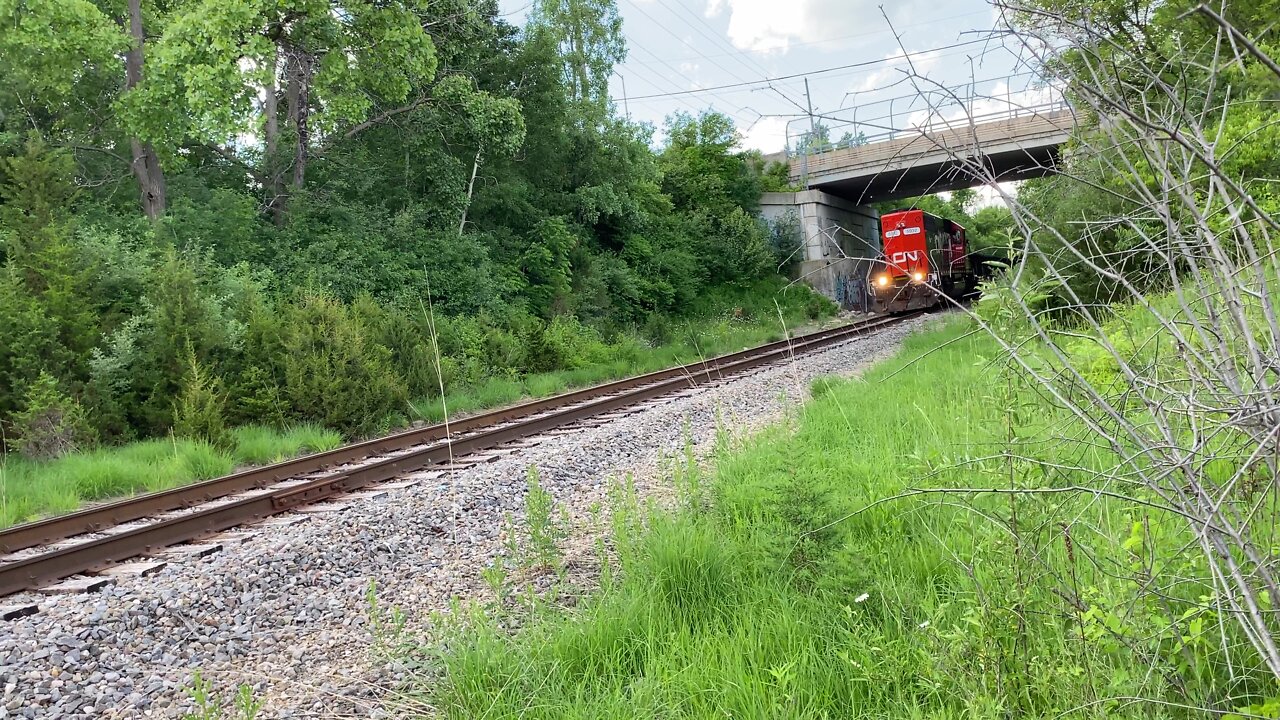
xmin=0 ymin=313 xmax=919 ymax=597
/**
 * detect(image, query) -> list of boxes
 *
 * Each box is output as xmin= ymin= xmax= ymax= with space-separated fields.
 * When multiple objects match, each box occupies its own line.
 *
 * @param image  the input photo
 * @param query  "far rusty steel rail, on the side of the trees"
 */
xmin=0 ymin=313 xmax=870 ymax=555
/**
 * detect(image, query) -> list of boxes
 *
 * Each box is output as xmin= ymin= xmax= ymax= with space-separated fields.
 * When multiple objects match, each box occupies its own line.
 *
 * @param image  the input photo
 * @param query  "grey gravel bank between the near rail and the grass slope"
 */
xmin=0 ymin=312 xmax=942 ymax=717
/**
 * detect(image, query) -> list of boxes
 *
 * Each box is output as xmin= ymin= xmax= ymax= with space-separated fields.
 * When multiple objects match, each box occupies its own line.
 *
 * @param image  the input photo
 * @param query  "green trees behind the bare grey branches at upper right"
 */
xmin=1016 ymin=0 xmax=1280 ymax=306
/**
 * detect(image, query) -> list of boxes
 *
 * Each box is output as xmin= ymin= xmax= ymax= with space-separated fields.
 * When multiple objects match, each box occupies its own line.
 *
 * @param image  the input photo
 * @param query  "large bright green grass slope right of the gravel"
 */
xmin=421 ymin=317 xmax=1275 ymax=719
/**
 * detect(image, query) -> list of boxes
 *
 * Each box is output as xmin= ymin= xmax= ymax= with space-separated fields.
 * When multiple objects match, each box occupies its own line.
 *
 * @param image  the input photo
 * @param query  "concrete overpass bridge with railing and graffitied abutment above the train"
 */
xmin=760 ymin=77 xmax=1075 ymax=309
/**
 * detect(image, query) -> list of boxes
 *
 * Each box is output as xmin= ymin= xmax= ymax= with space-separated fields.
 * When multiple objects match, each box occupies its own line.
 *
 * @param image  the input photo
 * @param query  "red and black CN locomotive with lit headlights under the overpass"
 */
xmin=870 ymin=210 xmax=977 ymax=313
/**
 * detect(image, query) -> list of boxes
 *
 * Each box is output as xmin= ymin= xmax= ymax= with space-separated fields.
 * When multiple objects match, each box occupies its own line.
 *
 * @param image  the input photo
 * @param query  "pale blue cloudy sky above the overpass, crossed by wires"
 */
xmin=499 ymin=0 xmax=1048 ymax=152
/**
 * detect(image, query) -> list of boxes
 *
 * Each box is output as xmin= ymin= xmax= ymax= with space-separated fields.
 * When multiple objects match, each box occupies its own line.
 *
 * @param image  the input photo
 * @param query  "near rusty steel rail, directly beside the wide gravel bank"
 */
xmin=0 ymin=313 xmax=919 ymax=596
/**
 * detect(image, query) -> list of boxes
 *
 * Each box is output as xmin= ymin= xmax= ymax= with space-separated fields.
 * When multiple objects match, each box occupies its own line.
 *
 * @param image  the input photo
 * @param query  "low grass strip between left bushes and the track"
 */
xmin=0 ymin=424 xmax=342 ymax=527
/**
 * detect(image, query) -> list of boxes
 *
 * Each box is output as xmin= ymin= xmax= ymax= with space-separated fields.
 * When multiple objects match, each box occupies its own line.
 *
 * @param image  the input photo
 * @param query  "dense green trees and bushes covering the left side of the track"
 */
xmin=0 ymin=0 xmax=829 ymax=514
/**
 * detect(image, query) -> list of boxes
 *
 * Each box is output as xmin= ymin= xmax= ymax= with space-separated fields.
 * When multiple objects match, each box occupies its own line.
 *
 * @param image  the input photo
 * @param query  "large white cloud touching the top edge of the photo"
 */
xmin=707 ymin=0 xmax=916 ymax=53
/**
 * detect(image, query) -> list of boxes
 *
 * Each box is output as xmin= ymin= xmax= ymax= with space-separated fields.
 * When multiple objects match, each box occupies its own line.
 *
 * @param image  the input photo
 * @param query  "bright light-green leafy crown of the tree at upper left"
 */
xmin=128 ymin=0 xmax=436 ymax=147
